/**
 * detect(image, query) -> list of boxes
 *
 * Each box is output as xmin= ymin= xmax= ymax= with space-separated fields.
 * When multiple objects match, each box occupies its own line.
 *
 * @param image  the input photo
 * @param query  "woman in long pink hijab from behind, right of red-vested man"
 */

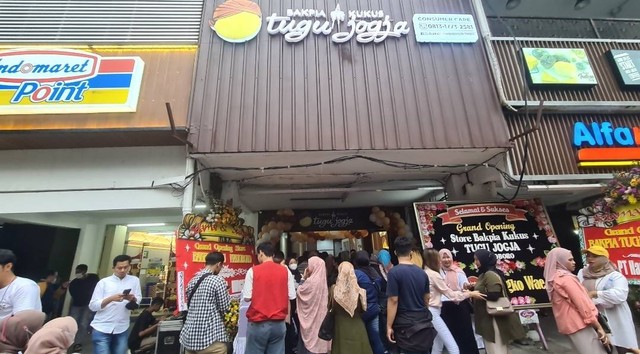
xmin=296 ymin=257 xmax=331 ymax=354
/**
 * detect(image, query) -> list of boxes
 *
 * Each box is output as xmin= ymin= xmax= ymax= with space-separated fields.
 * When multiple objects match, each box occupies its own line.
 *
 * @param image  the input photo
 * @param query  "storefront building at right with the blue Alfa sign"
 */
xmin=475 ymin=0 xmax=640 ymax=258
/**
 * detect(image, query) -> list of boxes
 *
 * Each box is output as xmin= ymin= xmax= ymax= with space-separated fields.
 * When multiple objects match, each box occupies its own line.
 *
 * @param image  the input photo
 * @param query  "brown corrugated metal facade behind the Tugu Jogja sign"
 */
xmin=190 ymin=0 xmax=507 ymax=153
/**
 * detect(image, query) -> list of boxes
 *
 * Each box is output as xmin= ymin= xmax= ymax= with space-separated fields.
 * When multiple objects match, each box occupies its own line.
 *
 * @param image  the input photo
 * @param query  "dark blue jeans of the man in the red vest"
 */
xmin=245 ymin=320 xmax=287 ymax=354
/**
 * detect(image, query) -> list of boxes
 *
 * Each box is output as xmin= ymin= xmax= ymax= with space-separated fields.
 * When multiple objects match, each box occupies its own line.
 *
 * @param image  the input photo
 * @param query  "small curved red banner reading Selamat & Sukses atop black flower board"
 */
xmin=438 ymin=203 xmax=527 ymax=225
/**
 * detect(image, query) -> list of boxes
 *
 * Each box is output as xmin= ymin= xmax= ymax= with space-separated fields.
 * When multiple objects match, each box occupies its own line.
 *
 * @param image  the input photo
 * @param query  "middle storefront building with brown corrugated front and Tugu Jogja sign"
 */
xmin=189 ymin=0 xmax=509 ymax=239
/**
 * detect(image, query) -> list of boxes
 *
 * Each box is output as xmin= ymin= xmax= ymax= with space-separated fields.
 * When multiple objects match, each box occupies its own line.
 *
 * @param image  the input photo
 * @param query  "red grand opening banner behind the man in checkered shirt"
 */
xmin=176 ymin=239 xmax=255 ymax=311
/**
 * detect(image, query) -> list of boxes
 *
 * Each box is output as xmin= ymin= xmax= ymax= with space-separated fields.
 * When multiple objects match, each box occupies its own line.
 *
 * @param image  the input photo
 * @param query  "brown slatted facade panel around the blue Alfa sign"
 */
xmin=506 ymin=113 xmax=640 ymax=175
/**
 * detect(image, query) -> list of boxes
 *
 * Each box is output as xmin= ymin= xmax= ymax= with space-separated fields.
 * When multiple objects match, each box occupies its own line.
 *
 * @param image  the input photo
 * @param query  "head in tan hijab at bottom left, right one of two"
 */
xmin=24 ymin=316 xmax=78 ymax=354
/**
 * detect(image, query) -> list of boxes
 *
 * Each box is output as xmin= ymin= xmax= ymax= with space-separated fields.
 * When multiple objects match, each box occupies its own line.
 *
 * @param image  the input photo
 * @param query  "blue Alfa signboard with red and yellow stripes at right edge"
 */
xmin=572 ymin=122 xmax=640 ymax=167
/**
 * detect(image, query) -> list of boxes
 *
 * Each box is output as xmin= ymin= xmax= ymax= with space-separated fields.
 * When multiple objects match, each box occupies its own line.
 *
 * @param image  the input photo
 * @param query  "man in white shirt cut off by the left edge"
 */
xmin=0 ymin=248 xmax=42 ymax=320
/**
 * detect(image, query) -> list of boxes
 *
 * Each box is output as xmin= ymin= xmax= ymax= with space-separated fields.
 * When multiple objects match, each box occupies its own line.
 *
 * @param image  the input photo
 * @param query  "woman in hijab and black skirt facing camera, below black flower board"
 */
xmin=438 ymin=248 xmax=480 ymax=354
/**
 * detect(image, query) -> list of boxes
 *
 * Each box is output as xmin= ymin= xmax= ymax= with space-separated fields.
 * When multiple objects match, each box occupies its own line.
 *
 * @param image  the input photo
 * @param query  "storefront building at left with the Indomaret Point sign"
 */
xmin=0 ymin=0 xmax=203 ymax=310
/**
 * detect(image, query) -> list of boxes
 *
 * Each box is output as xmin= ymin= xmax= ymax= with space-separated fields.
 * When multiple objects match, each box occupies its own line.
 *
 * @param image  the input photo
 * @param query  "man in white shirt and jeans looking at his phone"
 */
xmin=89 ymin=255 xmax=142 ymax=354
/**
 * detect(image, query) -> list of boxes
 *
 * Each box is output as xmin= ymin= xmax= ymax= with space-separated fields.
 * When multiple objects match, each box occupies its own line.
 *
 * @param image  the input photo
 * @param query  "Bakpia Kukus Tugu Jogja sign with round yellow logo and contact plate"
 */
xmin=209 ymin=0 xmax=478 ymax=43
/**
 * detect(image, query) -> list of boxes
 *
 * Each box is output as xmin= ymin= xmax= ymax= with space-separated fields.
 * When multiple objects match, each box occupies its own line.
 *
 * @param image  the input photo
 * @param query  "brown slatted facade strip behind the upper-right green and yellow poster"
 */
xmin=491 ymin=38 xmax=640 ymax=105
